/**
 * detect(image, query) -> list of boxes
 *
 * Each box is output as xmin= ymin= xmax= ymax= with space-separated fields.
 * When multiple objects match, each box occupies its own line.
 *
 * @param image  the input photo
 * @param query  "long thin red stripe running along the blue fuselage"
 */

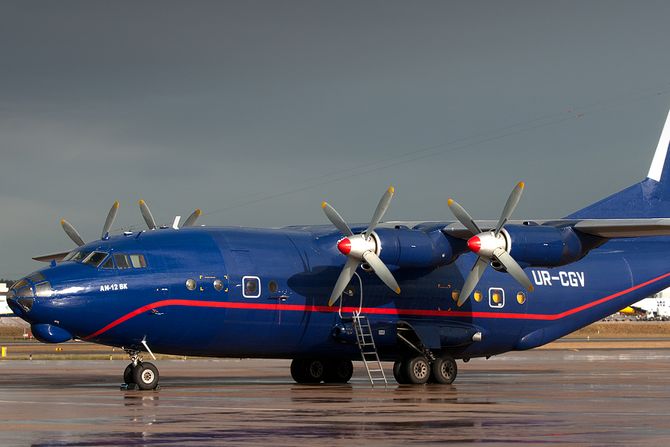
xmin=83 ymin=273 xmax=670 ymax=340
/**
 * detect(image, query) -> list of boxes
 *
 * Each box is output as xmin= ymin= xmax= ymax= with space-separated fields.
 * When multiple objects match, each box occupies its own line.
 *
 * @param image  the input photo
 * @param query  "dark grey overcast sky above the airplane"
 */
xmin=0 ymin=1 xmax=670 ymax=278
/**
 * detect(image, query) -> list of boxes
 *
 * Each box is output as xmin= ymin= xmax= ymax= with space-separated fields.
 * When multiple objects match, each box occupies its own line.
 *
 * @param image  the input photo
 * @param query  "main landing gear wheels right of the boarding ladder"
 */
xmin=393 ymin=355 xmax=458 ymax=385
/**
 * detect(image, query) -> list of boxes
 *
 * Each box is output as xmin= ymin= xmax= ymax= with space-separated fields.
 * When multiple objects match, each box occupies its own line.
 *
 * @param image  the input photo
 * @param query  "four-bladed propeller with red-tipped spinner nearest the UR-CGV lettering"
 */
xmin=447 ymin=182 xmax=533 ymax=307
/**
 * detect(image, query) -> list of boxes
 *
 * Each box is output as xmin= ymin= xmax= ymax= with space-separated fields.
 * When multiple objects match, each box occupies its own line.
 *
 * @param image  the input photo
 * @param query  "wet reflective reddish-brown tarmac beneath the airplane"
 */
xmin=0 ymin=349 xmax=670 ymax=446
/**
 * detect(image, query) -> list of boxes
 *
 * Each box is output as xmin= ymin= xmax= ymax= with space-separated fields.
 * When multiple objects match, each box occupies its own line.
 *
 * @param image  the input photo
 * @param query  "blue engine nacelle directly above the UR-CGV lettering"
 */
xmin=503 ymin=225 xmax=594 ymax=267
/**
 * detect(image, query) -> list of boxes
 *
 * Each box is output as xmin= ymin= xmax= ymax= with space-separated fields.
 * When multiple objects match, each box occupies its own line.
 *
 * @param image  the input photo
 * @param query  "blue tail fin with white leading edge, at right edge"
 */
xmin=567 ymin=112 xmax=670 ymax=219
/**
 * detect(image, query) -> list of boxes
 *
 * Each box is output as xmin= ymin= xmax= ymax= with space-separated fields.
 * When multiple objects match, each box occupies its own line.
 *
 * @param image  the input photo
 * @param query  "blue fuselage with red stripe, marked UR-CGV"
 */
xmin=9 ymin=227 xmax=670 ymax=360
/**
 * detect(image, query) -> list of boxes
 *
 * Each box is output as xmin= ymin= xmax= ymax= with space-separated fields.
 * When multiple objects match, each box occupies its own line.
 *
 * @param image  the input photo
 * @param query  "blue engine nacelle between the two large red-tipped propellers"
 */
xmin=375 ymin=227 xmax=457 ymax=268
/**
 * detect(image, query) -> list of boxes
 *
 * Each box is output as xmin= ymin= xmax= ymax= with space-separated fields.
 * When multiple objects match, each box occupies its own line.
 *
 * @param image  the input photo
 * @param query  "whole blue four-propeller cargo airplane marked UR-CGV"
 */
xmin=8 ymin=110 xmax=670 ymax=389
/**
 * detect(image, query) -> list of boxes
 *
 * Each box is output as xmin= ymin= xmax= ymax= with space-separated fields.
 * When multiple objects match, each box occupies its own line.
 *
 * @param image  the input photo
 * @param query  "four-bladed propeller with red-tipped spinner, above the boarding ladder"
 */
xmin=321 ymin=186 xmax=400 ymax=306
